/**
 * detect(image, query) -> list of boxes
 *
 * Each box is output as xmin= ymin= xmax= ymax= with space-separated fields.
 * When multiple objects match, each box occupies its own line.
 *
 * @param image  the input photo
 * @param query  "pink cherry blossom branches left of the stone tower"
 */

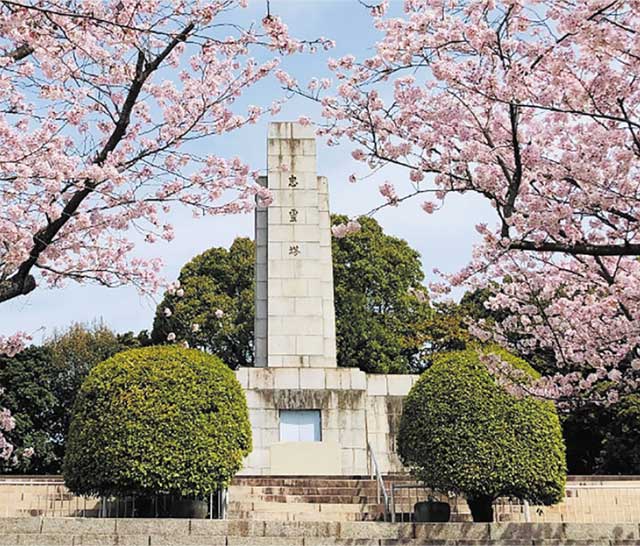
xmin=0 ymin=0 xmax=331 ymax=457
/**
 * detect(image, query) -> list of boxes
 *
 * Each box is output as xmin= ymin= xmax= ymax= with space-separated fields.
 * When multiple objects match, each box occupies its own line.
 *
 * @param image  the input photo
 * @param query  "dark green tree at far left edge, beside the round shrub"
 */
xmin=0 ymin=347 xmax=62 ymax=474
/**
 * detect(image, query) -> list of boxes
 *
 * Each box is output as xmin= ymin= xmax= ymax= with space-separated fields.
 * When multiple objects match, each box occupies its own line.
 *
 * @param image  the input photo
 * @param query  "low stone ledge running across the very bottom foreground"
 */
xmin=0 ymin=517 xmax=640 ymax=546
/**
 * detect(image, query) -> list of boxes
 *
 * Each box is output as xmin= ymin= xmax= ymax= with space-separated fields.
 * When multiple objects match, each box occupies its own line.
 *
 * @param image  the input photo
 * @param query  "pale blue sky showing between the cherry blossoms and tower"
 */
xmin=0 ymin=0 xmax=491 ymax=343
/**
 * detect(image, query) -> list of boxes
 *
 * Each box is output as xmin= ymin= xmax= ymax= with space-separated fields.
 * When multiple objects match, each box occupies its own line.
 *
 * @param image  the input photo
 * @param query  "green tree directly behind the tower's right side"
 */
xmin=332 ymin=216 xmax=430 ymax=373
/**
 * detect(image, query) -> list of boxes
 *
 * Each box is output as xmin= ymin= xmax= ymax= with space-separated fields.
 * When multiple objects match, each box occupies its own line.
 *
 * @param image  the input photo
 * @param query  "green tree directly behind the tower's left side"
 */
xmin=151 ymin=238 xmax=255 ymax=369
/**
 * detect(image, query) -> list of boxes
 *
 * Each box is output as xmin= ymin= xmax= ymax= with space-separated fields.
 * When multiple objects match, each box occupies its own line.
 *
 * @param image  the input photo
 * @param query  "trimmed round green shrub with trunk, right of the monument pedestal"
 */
xmin=398 ymin=349 xmax=566 ymax=521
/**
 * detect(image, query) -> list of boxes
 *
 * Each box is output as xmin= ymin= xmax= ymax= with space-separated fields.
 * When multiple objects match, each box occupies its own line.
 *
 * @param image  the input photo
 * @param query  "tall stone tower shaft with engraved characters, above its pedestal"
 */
xmin=255 ymin=122 xmax=337 ymax=368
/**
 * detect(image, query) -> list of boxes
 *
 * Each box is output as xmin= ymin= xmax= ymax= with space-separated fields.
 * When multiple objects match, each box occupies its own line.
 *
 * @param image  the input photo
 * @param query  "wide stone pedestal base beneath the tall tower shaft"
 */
xmin=236 ymin=368 xmax=419 ymax=476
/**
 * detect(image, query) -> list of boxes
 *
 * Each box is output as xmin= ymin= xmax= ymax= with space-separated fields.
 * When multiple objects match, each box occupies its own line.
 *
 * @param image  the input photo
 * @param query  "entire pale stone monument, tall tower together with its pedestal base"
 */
xmin=236 ymin=123 xmax=415 ymax=476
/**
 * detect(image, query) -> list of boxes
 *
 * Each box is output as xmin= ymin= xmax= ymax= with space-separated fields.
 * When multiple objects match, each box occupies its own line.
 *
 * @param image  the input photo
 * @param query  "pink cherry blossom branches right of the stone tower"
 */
xmin=292 ymin=0 xmax=640 ymax=402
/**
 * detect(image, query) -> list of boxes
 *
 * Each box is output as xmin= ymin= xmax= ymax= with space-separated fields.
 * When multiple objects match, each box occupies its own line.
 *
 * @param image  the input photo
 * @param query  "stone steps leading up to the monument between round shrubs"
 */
xmin=228 ymin=476 xmax=384 ymax=521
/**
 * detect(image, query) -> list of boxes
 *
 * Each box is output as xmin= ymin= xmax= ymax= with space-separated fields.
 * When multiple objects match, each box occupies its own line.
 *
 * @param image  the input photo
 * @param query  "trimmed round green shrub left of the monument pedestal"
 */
xmin=63 ymin=346 xmax=251 ymax=497
